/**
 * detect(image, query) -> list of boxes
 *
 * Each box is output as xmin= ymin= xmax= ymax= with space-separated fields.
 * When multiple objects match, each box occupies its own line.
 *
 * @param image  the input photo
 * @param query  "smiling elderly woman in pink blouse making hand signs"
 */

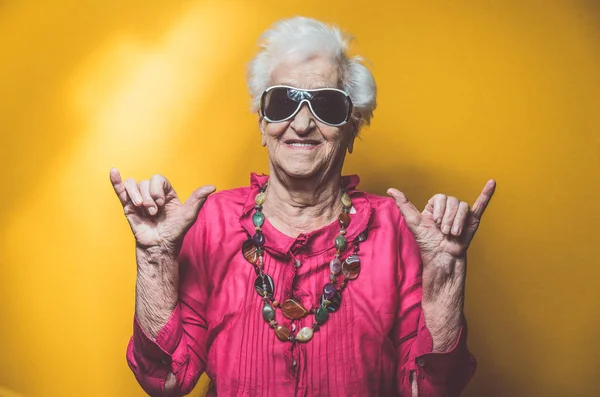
xmin=110 ymin=18 xmax=495 ymax=397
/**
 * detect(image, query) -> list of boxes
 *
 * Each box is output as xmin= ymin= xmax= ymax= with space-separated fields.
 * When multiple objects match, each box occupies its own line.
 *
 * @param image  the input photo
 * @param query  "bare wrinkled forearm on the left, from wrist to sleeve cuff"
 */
xmin=135 ymin=247 xmax=179 ymax=339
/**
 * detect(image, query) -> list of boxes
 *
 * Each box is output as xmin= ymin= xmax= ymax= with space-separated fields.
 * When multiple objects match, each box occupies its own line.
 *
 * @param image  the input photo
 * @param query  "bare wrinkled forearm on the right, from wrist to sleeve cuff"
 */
xmin=422 ymin=258 xmax=466 ymax=352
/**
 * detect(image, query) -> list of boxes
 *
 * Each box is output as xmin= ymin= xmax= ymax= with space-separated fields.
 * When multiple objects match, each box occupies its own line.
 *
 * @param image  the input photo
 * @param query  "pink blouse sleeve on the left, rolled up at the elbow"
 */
xmin=127 ymin=201 xmax=208 ymax=396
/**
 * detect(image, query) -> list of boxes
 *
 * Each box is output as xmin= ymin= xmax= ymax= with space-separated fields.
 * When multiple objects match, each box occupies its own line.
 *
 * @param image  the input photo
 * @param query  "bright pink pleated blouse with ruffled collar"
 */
xmin=127 ymin=174 xmax=476 ymax=397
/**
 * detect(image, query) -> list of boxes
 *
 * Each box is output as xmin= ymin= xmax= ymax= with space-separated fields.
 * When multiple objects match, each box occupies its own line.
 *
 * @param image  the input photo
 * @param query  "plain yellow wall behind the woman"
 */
xmin=0 ymin=0 xmax=600 ymax=397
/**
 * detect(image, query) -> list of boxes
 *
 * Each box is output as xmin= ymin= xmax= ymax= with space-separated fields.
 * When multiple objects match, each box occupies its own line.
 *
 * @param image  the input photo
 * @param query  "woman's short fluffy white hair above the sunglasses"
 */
xmin=248 ymin=17 xmax=377 ymax=126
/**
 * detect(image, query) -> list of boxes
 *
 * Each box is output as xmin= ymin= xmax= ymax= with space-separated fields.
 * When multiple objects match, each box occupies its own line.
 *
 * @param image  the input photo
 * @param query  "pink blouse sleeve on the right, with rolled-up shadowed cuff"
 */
xmin=394 ymin=218 xmax=477 ymax=397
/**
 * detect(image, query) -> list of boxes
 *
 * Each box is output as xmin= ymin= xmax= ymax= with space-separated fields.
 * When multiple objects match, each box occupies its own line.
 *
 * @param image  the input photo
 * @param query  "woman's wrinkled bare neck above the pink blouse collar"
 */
xmin=263 ymin=172 xmax=342 ymax=237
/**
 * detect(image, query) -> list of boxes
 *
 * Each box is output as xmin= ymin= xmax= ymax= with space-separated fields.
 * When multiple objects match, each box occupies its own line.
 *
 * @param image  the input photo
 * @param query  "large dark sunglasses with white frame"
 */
xmin=260 ymin=85 xmax=352 ymax=127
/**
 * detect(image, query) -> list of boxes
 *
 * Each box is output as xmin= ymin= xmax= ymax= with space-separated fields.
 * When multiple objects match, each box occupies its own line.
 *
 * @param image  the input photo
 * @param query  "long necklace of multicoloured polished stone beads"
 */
xmin=242 ymin=184 xmax=367 ymax=343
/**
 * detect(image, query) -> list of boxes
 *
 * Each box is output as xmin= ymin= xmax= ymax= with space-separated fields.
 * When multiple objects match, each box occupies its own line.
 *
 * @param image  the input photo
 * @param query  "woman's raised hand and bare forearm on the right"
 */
xmin=388 ymin=180 xmax=496 ymax=350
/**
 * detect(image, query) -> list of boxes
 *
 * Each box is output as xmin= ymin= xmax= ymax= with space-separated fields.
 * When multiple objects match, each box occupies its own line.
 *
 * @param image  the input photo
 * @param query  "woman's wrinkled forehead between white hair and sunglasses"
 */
xmin=269 ymin=55 xmax=341 ymax=89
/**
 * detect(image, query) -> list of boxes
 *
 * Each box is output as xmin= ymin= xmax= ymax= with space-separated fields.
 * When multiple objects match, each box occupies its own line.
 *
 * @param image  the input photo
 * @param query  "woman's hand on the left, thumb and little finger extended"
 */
xmin=110 ymin=168 xmax=215 ymax=259
